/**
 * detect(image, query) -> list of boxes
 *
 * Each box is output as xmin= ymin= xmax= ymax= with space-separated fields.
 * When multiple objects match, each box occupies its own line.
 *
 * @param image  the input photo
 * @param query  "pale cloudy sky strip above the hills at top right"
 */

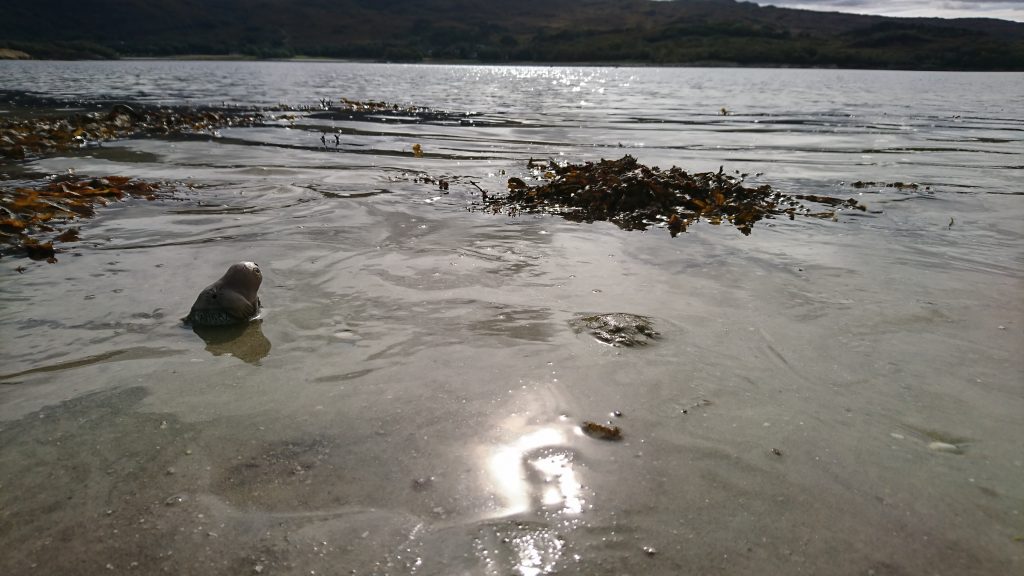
xmin=755 ymin=0 xmax=1024 ymax=22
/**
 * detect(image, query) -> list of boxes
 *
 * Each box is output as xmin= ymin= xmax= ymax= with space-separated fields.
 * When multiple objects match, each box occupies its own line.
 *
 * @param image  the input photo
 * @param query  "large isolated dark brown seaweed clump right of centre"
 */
xmin=484 ymin=155 xmax=864 ymax=237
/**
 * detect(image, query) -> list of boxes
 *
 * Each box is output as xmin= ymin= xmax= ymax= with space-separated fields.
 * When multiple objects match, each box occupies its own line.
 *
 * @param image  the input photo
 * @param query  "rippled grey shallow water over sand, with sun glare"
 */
xmin=0 ymin=61 xmax=1024 ymax=576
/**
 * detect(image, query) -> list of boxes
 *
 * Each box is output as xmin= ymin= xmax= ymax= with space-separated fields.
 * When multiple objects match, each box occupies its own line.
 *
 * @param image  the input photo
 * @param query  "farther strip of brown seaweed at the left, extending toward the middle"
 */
xmin=0 ymin=105 xmax=263 ymax=159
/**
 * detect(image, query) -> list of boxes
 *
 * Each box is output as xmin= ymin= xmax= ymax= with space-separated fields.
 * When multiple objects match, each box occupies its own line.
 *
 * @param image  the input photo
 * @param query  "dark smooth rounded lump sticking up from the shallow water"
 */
xmin=184 ymin=262 xmax=263 ymax=326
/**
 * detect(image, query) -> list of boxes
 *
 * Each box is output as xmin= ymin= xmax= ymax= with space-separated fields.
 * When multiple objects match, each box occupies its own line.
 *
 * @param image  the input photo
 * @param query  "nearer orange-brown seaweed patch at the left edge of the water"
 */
xmin=0 ymin=176 xmax=160 ymax=262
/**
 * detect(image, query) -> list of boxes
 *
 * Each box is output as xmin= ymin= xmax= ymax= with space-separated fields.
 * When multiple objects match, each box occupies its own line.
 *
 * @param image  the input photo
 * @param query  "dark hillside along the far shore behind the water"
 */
xmin=0 ymin=0 xmax=1024 ymax=71
